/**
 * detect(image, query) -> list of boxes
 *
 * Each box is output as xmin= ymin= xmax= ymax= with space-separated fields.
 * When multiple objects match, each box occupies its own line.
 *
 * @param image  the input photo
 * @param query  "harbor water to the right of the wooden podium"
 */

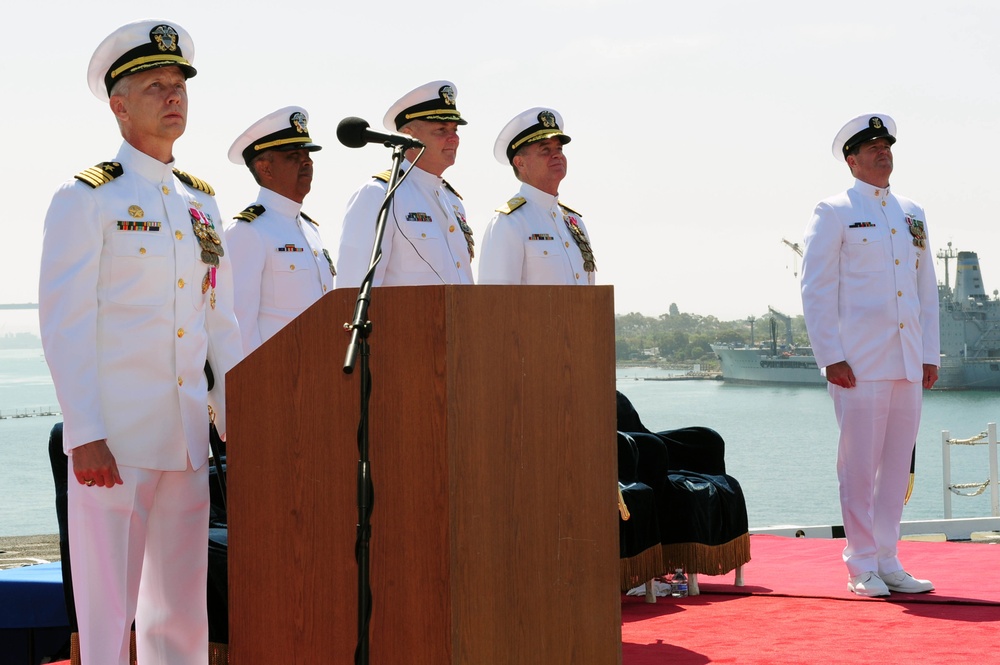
xmin=617 ymin=368 xmax=1000 ymax=528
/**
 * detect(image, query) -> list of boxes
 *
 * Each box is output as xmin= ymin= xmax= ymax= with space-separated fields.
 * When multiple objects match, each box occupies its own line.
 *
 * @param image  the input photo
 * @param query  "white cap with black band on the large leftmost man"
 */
xmin=87 ymin=19 xmax=198 ymax=102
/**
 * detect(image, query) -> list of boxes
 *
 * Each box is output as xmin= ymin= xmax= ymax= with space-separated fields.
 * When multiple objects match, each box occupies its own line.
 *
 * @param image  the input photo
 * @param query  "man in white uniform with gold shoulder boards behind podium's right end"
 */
xmin=479 ymin=107 xmax=597 ymax=286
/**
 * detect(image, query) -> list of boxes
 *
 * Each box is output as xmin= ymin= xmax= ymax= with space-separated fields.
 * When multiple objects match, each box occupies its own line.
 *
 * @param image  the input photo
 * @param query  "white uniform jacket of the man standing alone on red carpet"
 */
xmin=802 ymin=180 xmax=941 ymax=383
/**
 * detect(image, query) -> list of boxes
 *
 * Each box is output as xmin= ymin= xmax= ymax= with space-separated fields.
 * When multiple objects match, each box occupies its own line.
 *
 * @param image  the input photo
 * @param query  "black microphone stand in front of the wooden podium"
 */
xmin=344 ymin=143 xmax=410 ymax=665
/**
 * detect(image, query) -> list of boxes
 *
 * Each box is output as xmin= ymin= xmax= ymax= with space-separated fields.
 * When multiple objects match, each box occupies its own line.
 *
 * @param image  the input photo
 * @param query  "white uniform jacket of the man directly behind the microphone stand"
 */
xmin=337 ymin=161 xmax=473 ymax=287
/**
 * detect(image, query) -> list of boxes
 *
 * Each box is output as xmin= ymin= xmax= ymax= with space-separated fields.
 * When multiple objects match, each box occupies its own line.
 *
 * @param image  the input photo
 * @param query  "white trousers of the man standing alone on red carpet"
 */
xmin=827 ymin=379 xmax=923 ymax=576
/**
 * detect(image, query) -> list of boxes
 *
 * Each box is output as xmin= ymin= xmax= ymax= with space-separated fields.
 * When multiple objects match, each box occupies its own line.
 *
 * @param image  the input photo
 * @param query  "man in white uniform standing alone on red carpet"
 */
xmin=802 ymin=114 xmax=941 ymax=596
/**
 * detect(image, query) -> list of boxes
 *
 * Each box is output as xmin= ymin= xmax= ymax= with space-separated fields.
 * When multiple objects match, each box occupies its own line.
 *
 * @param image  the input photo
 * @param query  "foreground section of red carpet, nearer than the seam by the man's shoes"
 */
xmin=622 ymin=595 xmax=1000 ymax=665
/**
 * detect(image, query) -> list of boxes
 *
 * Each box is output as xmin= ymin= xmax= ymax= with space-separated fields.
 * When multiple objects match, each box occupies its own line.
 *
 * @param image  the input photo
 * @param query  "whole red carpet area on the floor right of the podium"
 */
xmin=622 ymin=535 xmax=1000 ymax=665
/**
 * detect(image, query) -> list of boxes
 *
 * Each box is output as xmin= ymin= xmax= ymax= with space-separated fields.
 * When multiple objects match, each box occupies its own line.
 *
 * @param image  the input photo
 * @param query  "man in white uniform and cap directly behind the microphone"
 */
xmin=337 ymin=81 xmax=475 ymax=287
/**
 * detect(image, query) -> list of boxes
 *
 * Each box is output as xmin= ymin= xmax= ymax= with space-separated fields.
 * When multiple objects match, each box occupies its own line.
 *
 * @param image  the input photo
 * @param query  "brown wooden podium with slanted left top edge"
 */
xmin=226 ymin=286 xmax=621 ymax=665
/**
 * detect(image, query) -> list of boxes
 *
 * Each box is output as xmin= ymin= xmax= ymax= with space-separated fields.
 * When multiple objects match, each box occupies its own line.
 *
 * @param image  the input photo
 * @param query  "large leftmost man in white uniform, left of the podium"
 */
xmin=39 ymin=20 xmax=241 ymax=665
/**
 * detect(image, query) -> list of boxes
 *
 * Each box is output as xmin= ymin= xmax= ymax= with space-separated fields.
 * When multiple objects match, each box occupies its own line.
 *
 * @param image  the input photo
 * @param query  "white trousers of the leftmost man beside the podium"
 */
xmin=69 ymin=463 xmax=209 ymax=665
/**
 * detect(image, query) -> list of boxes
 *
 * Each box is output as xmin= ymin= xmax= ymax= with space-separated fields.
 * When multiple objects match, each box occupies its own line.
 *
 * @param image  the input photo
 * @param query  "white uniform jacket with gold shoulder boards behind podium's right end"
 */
xmin=479 ymin=183 xmax=595 ymax=286
